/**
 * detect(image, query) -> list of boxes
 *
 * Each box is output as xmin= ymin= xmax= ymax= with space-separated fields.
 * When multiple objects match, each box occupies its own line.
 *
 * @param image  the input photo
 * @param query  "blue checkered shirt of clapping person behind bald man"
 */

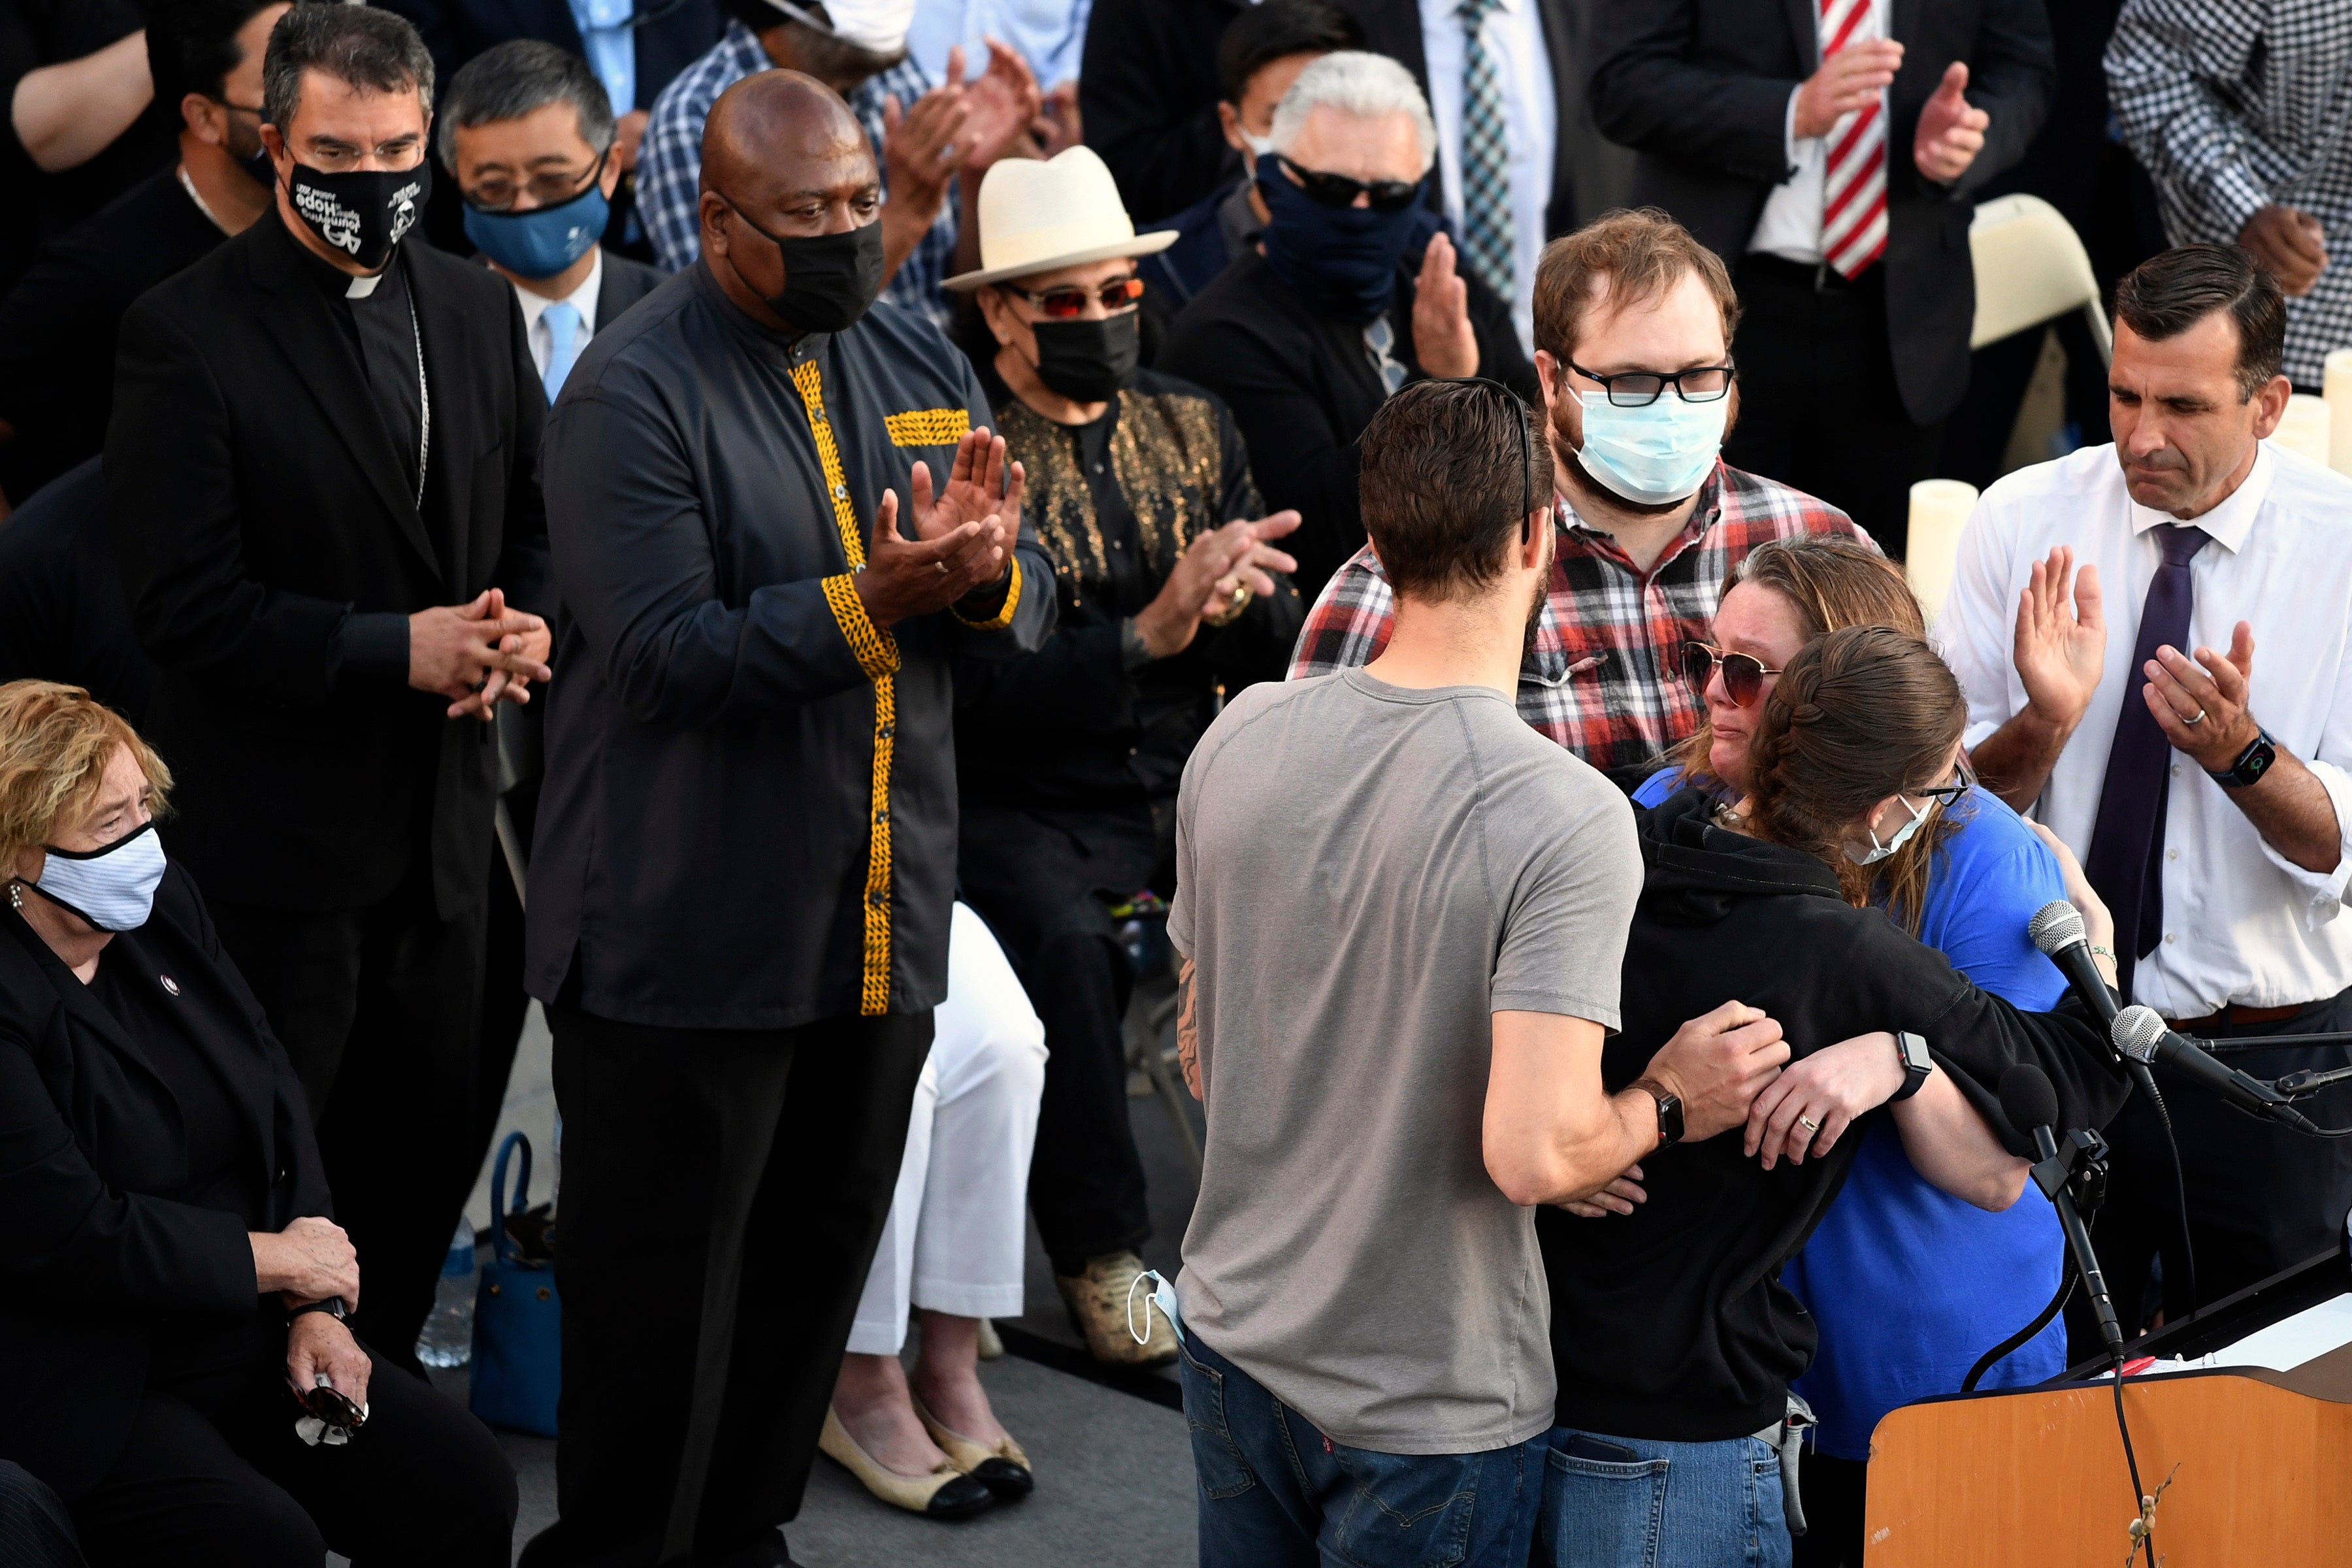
xmin=638 ymin=21 xmax=955 ymax=327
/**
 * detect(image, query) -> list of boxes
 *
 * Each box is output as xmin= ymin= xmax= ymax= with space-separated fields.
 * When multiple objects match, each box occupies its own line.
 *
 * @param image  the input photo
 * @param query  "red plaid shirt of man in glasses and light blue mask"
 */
xmin=1291 ymin=463 xmax=1870 ymax=769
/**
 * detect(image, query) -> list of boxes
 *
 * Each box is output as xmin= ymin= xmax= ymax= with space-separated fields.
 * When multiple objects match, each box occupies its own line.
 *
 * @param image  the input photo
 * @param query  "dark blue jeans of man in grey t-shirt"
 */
xmin=1179 ymin=1335 xmax=1552 ymax=1568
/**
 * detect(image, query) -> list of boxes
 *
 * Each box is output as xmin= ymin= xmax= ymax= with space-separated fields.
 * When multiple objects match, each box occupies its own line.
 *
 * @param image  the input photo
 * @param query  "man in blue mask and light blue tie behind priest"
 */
xmin=440 ymin=38 xmax=663 ymax=404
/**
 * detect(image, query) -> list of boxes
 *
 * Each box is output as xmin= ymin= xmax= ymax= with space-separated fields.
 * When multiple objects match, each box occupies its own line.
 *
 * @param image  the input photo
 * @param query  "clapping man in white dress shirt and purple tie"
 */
xmin=1938 ymin=244 xmax=2352 ymax=1328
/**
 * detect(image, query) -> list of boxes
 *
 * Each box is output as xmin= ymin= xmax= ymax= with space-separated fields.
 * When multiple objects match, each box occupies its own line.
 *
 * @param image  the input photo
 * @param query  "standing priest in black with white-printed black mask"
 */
xmin=106 ymin=5 xmax=548 ymax=1361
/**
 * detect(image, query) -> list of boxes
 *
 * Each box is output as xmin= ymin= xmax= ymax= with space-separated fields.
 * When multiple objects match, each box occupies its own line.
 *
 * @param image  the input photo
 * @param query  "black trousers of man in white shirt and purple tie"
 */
xmin=2067 ymin=990 xmax=2352 ymax=1361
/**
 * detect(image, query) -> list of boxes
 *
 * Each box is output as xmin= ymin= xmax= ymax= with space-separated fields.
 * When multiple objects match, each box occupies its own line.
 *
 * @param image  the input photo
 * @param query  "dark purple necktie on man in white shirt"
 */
xmin=2082 ymin=524 xmax=2208 ymax=1002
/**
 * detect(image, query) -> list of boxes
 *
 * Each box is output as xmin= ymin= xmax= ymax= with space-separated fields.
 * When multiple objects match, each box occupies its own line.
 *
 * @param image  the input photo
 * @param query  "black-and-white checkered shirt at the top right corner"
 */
xmin=2108 ymin=0 xmax=2352 ymax=393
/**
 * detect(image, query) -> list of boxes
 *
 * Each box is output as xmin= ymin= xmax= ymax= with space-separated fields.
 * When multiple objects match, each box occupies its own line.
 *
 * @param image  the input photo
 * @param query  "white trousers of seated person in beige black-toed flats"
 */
xmin=849 ymin=903 xmax=1044 ymax=1356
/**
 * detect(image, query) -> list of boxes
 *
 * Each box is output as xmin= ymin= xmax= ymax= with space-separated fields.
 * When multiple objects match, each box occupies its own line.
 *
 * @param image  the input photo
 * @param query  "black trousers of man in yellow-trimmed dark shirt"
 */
xmin=522 ymin=1004 xmax=932 ymax=1568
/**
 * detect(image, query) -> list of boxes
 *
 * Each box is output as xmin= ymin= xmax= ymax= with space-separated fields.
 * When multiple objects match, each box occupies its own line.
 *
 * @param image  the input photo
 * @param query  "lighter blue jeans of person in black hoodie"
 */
xmin=1536 ymin=1427 xmax=1790 ymax=1568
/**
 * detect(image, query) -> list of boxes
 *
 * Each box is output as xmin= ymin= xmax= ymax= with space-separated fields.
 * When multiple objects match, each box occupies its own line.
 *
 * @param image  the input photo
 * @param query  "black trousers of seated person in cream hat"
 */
xmin=957 ymin=804 xmax=1173 ymax=1274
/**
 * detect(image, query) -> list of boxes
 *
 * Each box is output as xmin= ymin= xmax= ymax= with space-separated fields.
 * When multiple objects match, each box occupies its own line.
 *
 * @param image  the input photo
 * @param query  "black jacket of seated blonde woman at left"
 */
xmin=0 ymin=863 xmax=334 ymax=1497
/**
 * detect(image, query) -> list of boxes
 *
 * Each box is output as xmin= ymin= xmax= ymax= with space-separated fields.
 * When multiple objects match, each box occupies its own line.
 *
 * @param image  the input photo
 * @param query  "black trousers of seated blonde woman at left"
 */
xmin=73 ymin=1352 xmax=515 ymax=1568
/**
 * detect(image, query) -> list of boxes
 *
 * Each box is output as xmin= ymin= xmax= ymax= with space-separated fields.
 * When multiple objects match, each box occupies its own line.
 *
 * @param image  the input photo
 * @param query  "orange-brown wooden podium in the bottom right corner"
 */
xmin=1863 ymin=1250 xmax=2352 ymax=1568
